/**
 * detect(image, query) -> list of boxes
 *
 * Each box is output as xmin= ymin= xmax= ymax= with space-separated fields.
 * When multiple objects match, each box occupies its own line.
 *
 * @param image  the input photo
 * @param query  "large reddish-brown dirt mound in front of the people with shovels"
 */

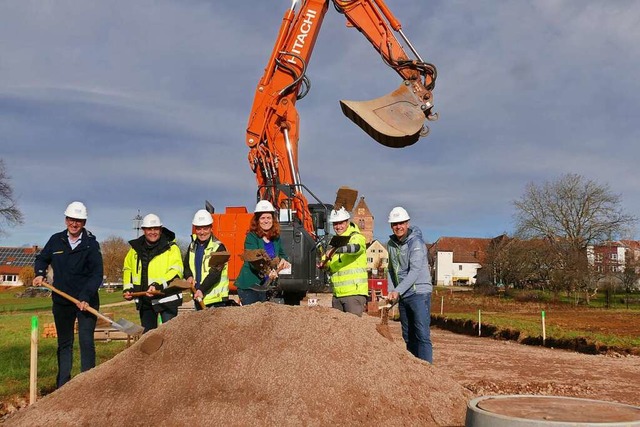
xmin=7 ymin=303 xmax=470 ymax=426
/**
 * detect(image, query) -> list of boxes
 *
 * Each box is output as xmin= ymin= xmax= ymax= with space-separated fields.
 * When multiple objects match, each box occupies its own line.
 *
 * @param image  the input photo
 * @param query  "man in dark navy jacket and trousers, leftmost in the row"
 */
xmin=33 ymin=202 xmax=103 ymax=388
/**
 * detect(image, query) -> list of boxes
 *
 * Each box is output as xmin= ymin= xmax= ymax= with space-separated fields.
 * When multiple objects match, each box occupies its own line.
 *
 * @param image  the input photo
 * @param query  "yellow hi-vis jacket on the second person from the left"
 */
xmin=122 ymin=244 xmax=183 ymax=303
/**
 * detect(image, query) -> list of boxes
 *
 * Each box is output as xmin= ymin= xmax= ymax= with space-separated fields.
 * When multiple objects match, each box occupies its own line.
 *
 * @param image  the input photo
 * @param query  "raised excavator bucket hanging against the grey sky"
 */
xmin=340 ymin=84 xmax=428 ymax=148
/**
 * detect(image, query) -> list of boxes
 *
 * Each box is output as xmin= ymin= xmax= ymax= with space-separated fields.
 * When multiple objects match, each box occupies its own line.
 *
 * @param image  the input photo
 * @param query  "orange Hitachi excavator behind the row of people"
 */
xmin=210 ymin=0 xmax=437 ymax=305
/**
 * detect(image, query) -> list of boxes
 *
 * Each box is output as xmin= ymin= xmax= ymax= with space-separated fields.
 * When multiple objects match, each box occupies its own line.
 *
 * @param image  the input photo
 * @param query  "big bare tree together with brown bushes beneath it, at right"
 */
xmin=477 ymin=174 xmax=640 ymax=303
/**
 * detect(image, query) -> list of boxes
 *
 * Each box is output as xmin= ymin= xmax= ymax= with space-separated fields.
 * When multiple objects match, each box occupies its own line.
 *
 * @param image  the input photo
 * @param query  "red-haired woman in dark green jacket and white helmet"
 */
xmin=235 ymin=200 xmax=291 ymax=305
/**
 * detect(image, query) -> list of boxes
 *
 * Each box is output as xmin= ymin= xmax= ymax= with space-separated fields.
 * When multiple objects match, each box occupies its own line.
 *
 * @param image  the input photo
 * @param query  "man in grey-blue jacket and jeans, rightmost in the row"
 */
xmin=387 ymin=206 xmax=433 ymax=363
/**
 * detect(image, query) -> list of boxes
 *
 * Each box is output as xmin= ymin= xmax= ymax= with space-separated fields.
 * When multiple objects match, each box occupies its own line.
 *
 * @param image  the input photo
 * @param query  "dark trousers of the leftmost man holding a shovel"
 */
xmin=51 ymin=303 xmax=99 ymax=388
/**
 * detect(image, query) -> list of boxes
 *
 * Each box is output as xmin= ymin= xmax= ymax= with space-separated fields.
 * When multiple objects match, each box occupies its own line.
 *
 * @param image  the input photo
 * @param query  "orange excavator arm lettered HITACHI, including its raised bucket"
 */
xmin=246 ymin=0 xmax=436 ymax=235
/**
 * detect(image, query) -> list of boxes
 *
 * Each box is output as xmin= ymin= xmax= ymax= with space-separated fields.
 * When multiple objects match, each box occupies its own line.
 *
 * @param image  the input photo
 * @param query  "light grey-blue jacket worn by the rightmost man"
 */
xmin=387 ymin=225 xmax=433 ymax=298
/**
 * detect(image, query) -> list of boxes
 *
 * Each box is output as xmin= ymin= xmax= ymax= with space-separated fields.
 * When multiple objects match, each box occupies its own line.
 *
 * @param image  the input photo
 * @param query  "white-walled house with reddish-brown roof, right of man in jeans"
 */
xmin=428 ymin=237 xmax=493 ymax=286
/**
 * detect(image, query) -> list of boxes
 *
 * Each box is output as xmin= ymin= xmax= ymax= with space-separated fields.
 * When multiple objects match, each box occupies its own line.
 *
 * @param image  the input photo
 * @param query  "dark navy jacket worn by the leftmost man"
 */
xmin=35 ymin=228 xmax=103 ymax=307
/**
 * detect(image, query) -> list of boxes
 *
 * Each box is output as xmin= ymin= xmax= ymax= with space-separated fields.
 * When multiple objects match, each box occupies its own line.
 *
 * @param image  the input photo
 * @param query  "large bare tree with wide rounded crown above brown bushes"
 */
xmin=514 ymin=174 xmax=637 ymax=250
